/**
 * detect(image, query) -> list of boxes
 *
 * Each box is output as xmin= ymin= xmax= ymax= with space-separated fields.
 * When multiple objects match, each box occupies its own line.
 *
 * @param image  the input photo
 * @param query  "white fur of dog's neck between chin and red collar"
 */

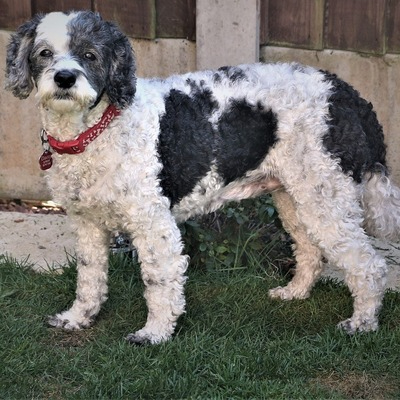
xmin=39 ymin=100 xmax=109 ymax=141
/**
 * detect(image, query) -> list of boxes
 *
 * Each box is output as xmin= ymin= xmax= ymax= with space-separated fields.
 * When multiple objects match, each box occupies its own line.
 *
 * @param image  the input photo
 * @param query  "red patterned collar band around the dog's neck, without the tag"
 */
xmin=47 ymin=104 xmax=121 ymax=154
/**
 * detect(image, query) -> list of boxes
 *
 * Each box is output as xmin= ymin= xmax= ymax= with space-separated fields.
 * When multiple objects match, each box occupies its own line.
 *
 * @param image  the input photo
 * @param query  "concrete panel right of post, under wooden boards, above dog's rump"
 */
xmin=260 ymin=46 xmax=400 ymax=185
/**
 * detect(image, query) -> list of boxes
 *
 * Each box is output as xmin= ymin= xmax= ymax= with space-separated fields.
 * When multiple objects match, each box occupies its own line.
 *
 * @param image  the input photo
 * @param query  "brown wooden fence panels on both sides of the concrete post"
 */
xmin=0 ymin=0 xmax=400 ymax=55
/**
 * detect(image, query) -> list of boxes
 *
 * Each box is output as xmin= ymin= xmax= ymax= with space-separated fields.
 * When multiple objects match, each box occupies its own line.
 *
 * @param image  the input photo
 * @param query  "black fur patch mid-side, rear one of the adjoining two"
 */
xmin=216 ymin=99 xmax=278 ymax=184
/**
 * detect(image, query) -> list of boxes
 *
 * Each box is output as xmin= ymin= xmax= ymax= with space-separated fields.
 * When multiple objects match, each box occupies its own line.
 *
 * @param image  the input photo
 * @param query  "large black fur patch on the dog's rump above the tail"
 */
xmin=321 ymin=71 xmax=386 ymax=183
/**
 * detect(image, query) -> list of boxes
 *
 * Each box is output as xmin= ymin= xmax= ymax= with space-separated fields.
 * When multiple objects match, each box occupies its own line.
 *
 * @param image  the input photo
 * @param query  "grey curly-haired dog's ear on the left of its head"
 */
xmin=5 ymin=15 xmax=43 ymax=99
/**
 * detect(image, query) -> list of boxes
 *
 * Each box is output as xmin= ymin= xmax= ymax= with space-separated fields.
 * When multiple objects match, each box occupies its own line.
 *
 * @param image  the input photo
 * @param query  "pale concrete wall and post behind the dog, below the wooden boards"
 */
xmin=0 ymin=0 xmax=400 ymax=199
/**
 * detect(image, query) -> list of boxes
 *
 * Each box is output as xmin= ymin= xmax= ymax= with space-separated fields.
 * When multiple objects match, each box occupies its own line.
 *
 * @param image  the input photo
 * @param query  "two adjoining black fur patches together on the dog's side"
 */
xmin=158 ymin=80 xmax=277 ymax=207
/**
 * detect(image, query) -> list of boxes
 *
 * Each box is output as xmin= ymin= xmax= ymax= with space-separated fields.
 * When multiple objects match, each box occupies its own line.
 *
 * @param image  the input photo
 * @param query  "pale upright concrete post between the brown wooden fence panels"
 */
xmin=196 ymin=0 xmax=260 ymax=69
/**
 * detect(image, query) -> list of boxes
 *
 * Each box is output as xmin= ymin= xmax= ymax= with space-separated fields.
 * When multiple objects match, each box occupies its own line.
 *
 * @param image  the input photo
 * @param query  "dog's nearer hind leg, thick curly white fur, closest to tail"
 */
xmin=276 ymin=164 xmax=387 ymax=333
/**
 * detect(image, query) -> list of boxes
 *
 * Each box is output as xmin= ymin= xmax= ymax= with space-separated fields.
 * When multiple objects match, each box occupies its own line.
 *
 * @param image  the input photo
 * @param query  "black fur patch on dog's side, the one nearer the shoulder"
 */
xmin=158 ymin=85 xmax=217 ymax=206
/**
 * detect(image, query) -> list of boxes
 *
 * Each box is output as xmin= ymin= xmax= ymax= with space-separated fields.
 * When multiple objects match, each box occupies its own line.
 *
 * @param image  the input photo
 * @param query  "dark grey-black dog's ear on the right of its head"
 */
xmin=106 ymin=22 xmax=136 ymax=109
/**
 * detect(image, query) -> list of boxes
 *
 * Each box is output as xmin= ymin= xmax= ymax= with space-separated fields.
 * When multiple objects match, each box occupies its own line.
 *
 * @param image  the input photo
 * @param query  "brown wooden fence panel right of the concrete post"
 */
xmin=260 ymin=0 xmax=400 ymax=54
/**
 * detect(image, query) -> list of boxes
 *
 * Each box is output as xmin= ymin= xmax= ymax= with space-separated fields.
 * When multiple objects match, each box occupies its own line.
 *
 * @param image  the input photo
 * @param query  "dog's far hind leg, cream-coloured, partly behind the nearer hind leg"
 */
xmin=269 ymin=190 xmax=322 ymax=300
